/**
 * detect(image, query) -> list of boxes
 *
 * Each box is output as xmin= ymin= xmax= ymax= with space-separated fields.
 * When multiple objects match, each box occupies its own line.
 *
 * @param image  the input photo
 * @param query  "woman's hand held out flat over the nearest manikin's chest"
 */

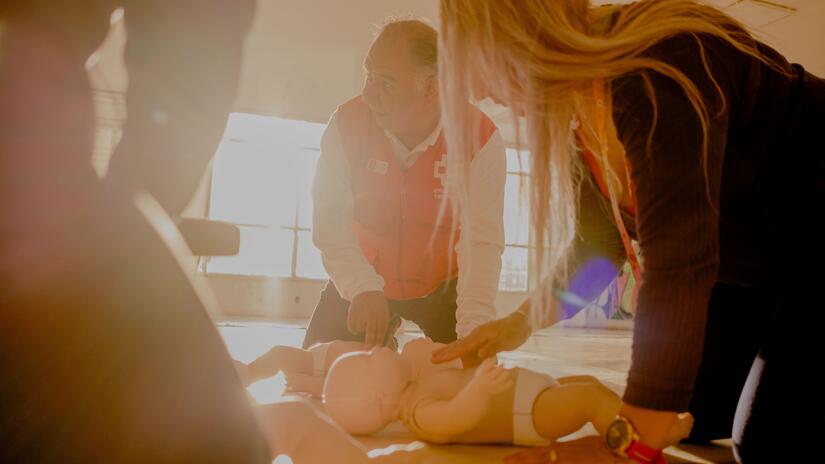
xmin=432 ymin=311 xmax=532 ymax=367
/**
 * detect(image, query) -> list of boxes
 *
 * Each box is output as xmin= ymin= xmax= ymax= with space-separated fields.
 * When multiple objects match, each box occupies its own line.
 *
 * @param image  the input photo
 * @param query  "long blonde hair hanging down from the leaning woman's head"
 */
xmin=439 ymin=0 xmax=762 ymax=326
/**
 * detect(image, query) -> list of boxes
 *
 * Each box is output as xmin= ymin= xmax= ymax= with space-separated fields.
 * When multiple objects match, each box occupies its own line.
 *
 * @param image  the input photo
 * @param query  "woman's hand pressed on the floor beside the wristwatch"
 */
xmin=504 ymin=436 xmax=634 ymax=464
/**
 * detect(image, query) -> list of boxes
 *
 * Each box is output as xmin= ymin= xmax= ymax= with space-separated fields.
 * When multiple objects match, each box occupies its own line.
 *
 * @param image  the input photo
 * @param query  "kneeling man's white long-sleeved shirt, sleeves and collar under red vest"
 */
xmin=312 ymin=113 xmax=507 ymax=337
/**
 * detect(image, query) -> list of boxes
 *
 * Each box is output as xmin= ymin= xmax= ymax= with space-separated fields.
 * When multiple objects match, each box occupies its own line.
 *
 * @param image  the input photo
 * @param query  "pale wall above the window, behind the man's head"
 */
xmin=233 ymin=0 xmax=437 ymax=122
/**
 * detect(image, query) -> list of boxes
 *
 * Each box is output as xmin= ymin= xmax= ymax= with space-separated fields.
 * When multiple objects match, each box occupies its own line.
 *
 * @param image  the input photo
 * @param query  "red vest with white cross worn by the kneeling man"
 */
xmin=337 ymin=96 xmax=496 ymax=300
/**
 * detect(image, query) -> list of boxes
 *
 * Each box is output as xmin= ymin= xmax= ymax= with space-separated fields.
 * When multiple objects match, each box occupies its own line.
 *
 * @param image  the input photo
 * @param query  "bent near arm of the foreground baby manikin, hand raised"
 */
xmin=412 ymin=359 xmax=513 ymax=442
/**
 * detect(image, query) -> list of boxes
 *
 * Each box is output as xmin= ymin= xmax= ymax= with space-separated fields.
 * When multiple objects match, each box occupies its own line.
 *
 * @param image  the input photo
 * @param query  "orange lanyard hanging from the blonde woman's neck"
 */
xmin=593 ymin=78 xmax=642 ymax=302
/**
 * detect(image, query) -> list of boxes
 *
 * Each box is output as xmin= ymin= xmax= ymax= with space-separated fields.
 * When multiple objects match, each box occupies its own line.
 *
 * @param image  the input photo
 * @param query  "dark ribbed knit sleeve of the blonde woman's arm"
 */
xmin=613 ymin=36 xmax=730 ymax=411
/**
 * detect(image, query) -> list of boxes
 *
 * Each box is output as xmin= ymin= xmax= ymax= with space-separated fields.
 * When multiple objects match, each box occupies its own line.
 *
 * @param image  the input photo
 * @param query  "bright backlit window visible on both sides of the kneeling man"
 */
xmin=205 ymin=113 xmax=529 ymax=292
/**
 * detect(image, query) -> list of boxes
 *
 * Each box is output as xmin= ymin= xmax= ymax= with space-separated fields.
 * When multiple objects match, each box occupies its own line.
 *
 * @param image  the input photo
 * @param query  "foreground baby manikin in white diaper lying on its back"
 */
xmin=323 ymin=348 xmax=692 ymax=445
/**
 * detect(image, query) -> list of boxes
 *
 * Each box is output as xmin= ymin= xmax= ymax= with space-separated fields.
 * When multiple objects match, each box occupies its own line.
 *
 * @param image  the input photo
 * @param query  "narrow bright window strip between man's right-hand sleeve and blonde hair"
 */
xmin=498 ymin=148 xmax=530 ymax=292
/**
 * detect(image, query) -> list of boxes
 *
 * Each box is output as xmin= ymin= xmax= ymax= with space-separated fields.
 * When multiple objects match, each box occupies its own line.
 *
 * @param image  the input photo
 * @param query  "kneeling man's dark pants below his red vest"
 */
xmin=304 ymin=279 xmax=457 ymax=348
